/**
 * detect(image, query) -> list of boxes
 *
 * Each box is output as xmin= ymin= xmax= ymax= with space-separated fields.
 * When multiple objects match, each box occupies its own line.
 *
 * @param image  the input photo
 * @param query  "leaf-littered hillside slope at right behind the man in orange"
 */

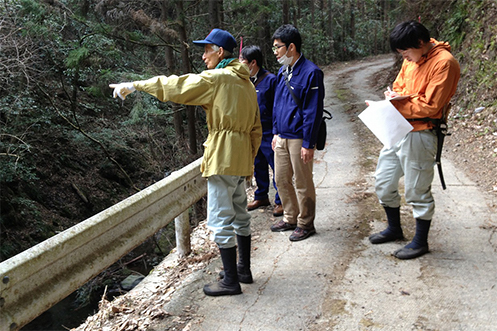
xmin=442 ymin=1 xmax=497 ymax=194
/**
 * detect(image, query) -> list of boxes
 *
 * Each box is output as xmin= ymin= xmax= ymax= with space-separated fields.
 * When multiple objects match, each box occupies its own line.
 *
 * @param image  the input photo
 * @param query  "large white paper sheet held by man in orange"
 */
xmin=359 ymin=100 xmax=413 ymax=148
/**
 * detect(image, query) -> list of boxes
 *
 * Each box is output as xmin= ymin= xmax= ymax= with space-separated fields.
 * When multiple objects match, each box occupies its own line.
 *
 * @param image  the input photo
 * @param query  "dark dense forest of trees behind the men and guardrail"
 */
xmin=0 ymin=0 xmax=497 ymax=261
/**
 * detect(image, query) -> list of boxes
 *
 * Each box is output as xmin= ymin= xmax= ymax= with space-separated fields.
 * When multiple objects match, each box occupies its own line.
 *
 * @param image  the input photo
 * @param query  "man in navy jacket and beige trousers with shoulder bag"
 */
xmin=271 ymin=24 xmax=324 ymax=241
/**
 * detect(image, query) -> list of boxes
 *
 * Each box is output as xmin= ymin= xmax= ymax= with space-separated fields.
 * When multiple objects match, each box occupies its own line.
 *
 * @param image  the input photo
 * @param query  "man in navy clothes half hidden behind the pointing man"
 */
xmin=240 ymin=45 xmax=283 ymax=216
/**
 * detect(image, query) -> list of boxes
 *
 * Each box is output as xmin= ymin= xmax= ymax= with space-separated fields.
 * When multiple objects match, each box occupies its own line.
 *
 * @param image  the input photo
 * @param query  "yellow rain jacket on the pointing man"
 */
xmin=133 ymin=59 xmax=262 ymax=177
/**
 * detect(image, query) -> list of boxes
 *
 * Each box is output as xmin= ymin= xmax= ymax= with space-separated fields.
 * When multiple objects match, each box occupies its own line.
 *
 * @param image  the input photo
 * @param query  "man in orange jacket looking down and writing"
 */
xmin=369 ymin=21 xmax=460 ymax=259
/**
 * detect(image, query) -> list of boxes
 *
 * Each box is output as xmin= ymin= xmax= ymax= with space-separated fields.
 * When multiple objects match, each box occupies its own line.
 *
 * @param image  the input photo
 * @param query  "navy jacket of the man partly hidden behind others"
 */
xmin=255 ymin=68 xmax=276 ymax=135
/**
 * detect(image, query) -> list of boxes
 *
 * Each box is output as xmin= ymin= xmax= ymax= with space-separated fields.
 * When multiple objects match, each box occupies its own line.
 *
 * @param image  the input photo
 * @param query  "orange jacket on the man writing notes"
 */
xmin=392 ymin=39 xmax=460 ymax=131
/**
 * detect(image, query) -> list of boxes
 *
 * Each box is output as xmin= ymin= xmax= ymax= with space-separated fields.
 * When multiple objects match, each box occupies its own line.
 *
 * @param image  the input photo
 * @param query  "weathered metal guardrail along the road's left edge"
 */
xmin=0 ymin=159 xmax=207 ymax=331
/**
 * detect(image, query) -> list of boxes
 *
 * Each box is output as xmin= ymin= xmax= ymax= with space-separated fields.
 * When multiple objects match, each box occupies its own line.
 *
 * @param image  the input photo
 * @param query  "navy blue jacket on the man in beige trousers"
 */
xmin=273 ymin=55 xmax=324 ymax=148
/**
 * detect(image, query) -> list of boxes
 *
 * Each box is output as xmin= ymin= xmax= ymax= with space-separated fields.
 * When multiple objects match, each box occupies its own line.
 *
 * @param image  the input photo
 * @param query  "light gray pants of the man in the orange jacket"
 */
xmin=375 ymin=130 xmax=437 ymax=220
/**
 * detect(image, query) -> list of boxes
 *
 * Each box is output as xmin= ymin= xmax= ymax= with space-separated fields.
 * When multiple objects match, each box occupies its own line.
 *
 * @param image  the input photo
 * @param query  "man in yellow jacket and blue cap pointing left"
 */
xmin=109 ymin=29 xmax=262 ymax=296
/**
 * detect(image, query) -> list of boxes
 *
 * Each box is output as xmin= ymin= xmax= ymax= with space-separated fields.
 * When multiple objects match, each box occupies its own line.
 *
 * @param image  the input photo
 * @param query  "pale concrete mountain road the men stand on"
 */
xmin=74 ymin=56 xmax=497 ymax=331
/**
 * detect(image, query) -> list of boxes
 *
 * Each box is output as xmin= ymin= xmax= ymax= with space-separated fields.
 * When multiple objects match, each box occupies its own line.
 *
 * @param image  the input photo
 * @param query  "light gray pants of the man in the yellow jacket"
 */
xmin=207 ymin=175 xmax=250 ymax=248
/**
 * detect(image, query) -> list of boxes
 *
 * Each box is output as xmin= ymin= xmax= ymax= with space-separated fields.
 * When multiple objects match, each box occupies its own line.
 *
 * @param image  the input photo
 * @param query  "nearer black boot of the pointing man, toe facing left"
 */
xmin=204 ymin=247 xmax=242 ymax=296
